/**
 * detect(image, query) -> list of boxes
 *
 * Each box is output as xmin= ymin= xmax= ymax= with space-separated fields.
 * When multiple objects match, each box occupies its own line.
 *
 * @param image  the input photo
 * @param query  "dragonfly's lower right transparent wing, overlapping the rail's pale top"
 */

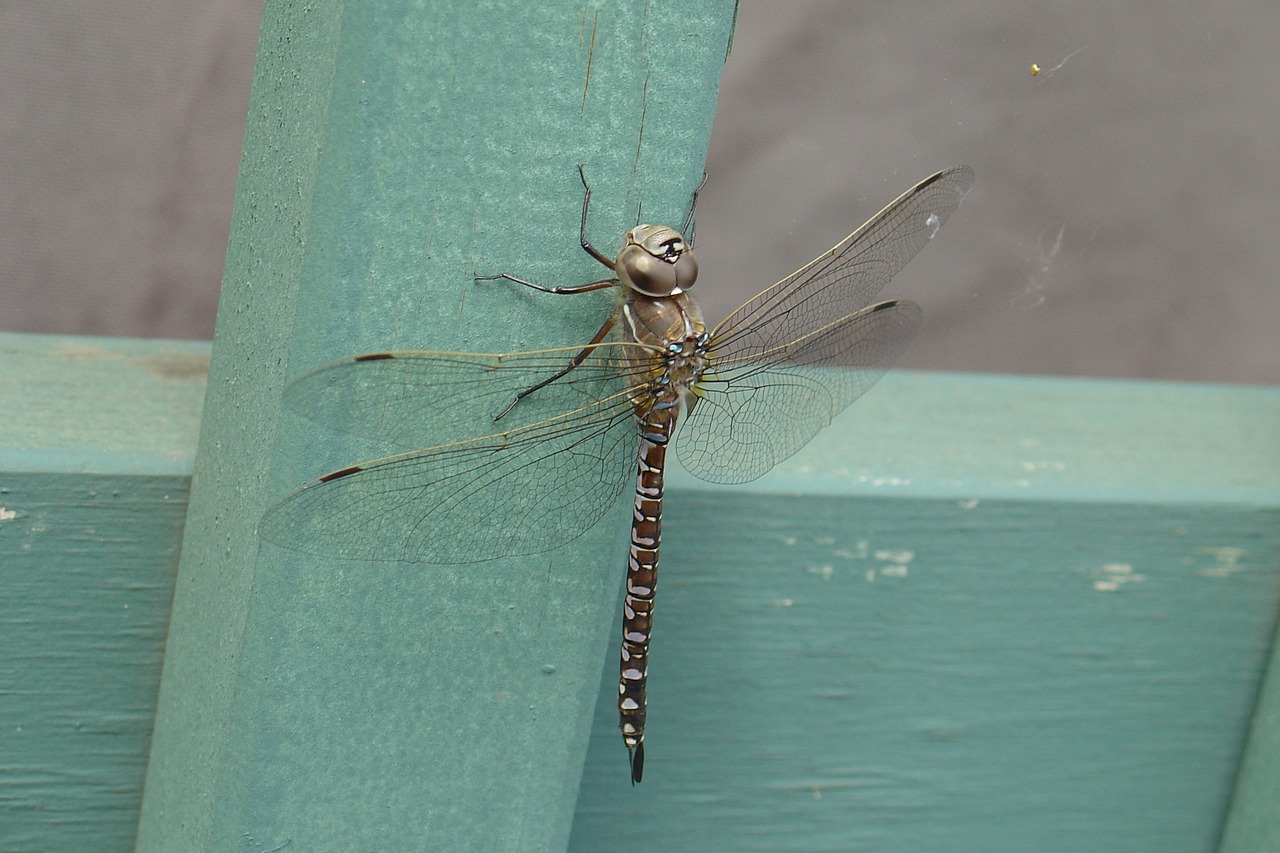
xmin=676 ymin=300 xmax=923 ymax=483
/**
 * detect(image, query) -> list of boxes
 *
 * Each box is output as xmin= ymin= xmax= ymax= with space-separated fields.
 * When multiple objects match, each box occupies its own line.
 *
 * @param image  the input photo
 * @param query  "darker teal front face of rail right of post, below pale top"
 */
xmin=571 ymin=491 xmax=1280 ymax=853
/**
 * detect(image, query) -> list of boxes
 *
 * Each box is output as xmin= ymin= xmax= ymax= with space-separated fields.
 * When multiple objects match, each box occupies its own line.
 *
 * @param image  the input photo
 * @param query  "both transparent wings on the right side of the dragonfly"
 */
xmin=676 ymin=167 xmax=973 ymax=483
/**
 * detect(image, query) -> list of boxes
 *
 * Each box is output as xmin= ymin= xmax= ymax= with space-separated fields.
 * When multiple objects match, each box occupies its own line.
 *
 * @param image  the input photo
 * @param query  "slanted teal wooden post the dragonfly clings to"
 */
xmin=138 ymin=0 xmax=733 ymax=850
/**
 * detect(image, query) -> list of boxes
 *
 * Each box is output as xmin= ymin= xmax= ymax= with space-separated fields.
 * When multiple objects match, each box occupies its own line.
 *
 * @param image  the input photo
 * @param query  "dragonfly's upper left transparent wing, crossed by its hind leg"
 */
xmin=284 ymin=343 xmax=645 ymax=450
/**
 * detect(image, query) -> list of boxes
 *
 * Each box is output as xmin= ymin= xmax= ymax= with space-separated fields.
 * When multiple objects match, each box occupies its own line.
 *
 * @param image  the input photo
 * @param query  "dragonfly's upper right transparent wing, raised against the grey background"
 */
xmin=709 ymin=167 xmax=973 ymax=359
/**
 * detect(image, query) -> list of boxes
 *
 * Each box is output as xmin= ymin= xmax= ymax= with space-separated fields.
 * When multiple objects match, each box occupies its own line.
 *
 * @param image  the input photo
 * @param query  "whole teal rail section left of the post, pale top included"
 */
xmin=0 ymin=334 xmax=209 ymax=850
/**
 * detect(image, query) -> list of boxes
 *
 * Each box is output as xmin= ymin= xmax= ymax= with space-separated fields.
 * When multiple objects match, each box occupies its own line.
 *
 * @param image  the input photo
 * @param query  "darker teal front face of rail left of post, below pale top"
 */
xmin=0 ymin=471 xmax=189 ymax=850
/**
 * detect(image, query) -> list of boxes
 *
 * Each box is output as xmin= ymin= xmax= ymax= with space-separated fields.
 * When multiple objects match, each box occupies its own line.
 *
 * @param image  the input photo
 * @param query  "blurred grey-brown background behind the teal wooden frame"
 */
xmin=0 ymin=0 xmax=1280 ymax=384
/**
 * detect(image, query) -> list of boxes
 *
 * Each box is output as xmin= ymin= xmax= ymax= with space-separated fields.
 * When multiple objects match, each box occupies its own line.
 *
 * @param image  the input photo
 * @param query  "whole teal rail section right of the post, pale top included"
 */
xmin=571 ymin=373 xmax=1280 ymax=852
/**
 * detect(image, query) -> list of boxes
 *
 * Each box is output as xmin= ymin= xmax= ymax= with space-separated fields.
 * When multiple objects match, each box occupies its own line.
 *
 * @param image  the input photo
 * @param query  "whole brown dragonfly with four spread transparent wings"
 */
xmin=259 ymin=165 xmax=973 ymax=785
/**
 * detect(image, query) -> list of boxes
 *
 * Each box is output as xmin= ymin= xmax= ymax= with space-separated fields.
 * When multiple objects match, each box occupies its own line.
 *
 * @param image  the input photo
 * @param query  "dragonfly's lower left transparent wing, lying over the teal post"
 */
xmin=259 ymin=393 xmax=636 ymax=564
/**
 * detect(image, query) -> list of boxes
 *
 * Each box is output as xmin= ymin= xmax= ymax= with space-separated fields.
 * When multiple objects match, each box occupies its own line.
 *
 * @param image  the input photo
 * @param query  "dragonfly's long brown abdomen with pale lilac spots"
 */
xmin=618 ymin=394 xmax=680 ymax=784
